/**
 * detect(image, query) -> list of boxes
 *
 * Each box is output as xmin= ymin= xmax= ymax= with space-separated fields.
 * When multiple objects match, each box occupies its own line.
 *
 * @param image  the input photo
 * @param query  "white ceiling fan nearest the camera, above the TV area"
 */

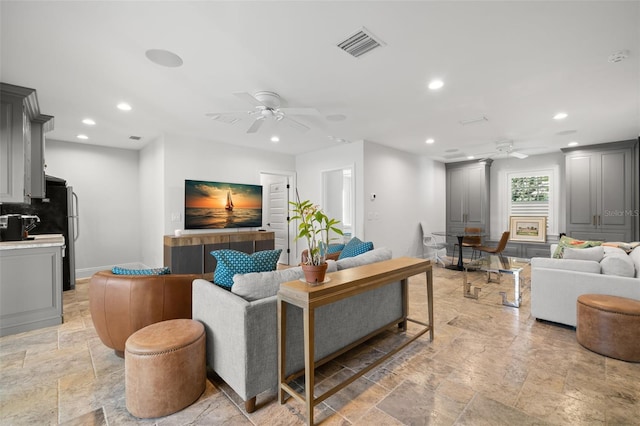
xmin=206 ymin=91 xmax=320 ymax=133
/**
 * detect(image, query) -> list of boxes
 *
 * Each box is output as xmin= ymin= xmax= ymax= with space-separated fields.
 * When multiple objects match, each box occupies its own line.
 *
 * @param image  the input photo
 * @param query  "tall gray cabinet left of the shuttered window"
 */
xmin=445 ymin=159 xmax=493 ymax=235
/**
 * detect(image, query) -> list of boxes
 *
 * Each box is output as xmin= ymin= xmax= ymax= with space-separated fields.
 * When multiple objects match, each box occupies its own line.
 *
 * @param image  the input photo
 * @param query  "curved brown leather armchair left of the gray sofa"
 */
xmin=89 ymin=271 xmax=201 ymax=357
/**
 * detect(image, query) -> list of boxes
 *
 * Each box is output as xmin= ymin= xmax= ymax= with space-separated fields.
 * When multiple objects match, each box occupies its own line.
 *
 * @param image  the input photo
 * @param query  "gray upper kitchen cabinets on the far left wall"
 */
xmin=0 ymin=83 xmax=53 ymax=203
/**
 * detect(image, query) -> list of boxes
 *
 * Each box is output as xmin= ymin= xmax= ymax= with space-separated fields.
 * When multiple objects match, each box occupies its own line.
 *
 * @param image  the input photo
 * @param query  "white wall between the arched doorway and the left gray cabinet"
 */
xmin=364 ymin=142 xmax=446 ymax=257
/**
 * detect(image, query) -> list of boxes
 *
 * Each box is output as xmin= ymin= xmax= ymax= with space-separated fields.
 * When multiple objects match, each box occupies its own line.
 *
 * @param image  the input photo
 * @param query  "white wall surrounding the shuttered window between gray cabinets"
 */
xmin=489 ymin=152 xmax=566 ymax=241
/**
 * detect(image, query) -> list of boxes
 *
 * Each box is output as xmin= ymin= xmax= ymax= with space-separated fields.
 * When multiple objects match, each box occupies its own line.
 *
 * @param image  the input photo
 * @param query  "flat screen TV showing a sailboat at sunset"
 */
xmin=184 ymin=180 xmax=262 ymax=229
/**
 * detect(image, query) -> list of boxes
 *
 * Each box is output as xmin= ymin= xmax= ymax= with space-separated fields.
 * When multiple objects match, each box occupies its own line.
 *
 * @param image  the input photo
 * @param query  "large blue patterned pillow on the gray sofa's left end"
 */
xmin=211 ymin=249 xmax=282 ymax=288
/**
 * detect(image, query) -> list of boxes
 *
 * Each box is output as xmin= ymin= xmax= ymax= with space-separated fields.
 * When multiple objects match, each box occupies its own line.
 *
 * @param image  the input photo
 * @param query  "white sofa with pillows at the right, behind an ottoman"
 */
xmin=531 ymin=245 xmax=640 ymax=327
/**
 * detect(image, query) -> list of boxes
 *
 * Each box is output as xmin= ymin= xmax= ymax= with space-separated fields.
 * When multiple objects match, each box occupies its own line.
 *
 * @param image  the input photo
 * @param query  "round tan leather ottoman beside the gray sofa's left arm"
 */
xmin=124 ymin=319 xmax=206 ymax=418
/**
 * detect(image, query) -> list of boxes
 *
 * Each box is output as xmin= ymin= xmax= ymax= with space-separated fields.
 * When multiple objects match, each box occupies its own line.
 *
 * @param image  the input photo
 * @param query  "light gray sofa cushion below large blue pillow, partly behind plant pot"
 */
xmin=231 ymin=260 xmax=338 ymax=302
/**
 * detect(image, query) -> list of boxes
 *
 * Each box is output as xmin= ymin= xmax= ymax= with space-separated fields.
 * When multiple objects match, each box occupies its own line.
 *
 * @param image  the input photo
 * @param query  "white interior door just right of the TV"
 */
xmin=260 ymin=173 xmax=291 ymax=265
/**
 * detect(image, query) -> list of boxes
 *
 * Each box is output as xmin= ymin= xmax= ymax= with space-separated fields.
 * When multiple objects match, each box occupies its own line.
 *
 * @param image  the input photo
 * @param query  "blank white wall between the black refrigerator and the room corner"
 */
xmin=46 ymin=140 xmax=141 ymax=278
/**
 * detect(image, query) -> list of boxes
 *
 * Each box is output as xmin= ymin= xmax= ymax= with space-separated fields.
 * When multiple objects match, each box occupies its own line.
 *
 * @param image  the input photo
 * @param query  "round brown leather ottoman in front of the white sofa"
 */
xmin=576 ymin=294 xmax=640 ymax=362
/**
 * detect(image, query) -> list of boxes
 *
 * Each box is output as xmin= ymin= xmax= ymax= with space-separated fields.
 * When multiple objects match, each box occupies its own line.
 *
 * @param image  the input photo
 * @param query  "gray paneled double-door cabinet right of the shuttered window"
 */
xmin=562 ymin=140 xmax=640 ymax=241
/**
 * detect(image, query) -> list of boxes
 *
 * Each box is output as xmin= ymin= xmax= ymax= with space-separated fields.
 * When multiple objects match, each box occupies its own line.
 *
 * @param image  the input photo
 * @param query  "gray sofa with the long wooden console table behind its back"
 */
xmin=192 ymin=248 xmax=402 ymax=412
